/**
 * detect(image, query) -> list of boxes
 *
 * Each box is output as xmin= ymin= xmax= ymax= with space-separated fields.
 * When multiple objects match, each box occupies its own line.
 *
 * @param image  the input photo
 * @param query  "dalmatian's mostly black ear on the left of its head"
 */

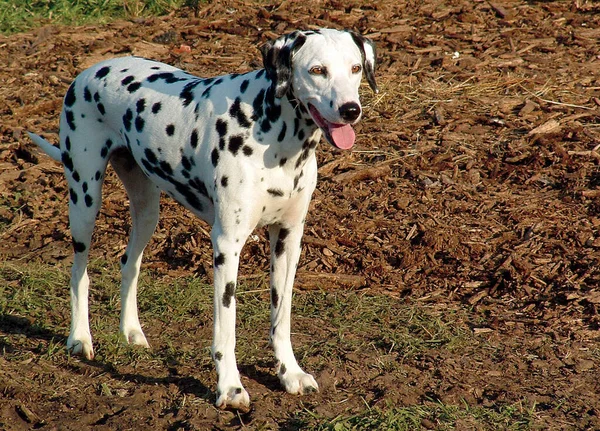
xmin=260 ymin=31 xmax=306 ymax=98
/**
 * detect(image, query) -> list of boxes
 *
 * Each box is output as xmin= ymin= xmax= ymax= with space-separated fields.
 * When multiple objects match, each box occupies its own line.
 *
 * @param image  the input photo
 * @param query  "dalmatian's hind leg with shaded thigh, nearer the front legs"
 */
xmin=110 ymin=149 xmax=160 ymax=347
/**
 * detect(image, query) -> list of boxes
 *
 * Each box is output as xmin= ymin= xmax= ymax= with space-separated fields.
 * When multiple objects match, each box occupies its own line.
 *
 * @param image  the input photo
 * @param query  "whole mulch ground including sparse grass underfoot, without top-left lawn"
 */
xmin=0 ymin=0 xmax=600 ymax=430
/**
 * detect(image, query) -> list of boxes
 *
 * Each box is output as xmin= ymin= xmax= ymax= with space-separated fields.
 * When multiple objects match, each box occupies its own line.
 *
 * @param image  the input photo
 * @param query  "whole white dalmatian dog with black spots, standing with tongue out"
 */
xmin=30 ymin=29 xmax=377 ymax=411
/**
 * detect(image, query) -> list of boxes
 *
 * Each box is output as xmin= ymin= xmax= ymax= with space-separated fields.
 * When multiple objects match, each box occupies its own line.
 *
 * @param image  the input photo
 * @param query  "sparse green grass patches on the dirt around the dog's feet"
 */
xmin=0 ymin=260 xmax=535 ymax=431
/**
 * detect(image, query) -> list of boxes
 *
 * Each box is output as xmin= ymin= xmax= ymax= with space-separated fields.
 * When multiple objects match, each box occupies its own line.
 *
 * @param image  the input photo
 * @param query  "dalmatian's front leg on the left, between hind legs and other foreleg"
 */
xmin=212 ymin=225 xmax=250 ymax=411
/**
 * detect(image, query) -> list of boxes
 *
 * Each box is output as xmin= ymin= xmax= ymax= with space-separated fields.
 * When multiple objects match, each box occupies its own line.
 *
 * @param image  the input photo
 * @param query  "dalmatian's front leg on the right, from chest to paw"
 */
xmin=269 ymin=223 xmax=319 ymax=394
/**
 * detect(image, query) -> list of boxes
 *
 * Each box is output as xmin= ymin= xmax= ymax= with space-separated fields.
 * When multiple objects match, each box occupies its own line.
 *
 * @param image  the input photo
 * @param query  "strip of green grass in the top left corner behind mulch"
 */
xmin=0 ymin=0 xmax=190 ymax=34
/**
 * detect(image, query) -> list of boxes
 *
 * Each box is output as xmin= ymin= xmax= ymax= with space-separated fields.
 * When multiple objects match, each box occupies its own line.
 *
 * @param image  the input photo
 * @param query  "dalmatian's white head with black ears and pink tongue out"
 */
xmin=261 ymin=29 xmax=378 ymax=149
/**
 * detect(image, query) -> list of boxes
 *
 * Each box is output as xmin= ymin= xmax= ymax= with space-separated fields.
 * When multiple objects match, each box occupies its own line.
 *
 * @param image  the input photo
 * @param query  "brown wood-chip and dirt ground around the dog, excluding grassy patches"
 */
xmin=0 ymin=0 xmax=600 ymax=429
